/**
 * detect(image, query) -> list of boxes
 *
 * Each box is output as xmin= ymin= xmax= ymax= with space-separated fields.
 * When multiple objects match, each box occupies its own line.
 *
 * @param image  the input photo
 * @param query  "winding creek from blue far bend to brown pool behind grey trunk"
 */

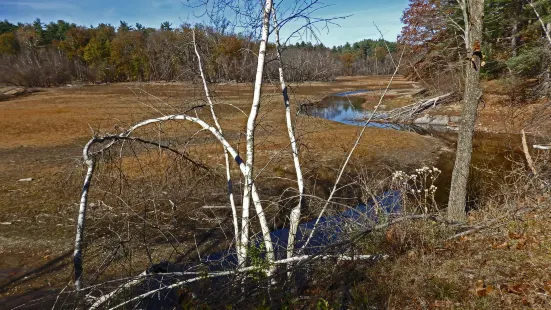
xmin=305 ymin=90 xmax=524 ymax=206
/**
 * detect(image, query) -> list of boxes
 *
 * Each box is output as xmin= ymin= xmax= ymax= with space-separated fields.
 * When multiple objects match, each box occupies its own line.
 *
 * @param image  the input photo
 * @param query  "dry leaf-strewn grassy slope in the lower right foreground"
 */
xmin=302 ymin=157 xmax=551 ymax=309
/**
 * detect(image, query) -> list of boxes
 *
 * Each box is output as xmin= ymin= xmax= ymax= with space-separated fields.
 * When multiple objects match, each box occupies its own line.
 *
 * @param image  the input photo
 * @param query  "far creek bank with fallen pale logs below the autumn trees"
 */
xmin=319 ymin=77 xmax=551 ymax=135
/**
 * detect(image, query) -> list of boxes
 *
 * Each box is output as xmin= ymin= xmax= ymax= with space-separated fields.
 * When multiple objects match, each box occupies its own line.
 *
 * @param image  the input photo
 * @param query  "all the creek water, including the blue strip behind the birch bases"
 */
xmin=124 ymin=90 xmax=522 ymax=309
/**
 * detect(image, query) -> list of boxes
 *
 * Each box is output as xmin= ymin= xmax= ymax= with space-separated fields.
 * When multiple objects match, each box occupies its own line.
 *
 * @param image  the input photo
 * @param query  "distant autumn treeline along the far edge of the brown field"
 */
xmin=0 ymin=19 xmax=395 ymax=87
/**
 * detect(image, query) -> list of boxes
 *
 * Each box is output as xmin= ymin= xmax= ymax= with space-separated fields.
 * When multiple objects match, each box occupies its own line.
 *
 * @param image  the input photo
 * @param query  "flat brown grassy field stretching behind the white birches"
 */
xmin=0 ymin=77 xmax=441 ymax=304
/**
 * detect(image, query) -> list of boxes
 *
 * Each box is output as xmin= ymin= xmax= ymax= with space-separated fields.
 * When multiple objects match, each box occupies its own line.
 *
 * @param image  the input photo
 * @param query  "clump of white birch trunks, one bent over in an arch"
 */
xmin=70 ymin=0 xmax=388 ymax=309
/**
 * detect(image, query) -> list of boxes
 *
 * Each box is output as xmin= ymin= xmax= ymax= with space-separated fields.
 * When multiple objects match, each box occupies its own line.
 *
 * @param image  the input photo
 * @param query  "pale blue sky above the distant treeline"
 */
xmin=0 ymin=0 xmax=408 ymax=46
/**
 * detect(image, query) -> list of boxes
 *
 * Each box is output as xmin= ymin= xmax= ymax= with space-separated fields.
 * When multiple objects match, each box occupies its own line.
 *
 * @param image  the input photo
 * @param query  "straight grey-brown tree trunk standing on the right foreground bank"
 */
xmin=448 ymin=0 xmax=484 ymax=221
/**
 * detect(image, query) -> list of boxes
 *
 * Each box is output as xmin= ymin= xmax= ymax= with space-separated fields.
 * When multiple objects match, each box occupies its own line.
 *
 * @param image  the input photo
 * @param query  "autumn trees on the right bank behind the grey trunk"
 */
xmin=398 ymin=0 xmax=551 ymax=95
